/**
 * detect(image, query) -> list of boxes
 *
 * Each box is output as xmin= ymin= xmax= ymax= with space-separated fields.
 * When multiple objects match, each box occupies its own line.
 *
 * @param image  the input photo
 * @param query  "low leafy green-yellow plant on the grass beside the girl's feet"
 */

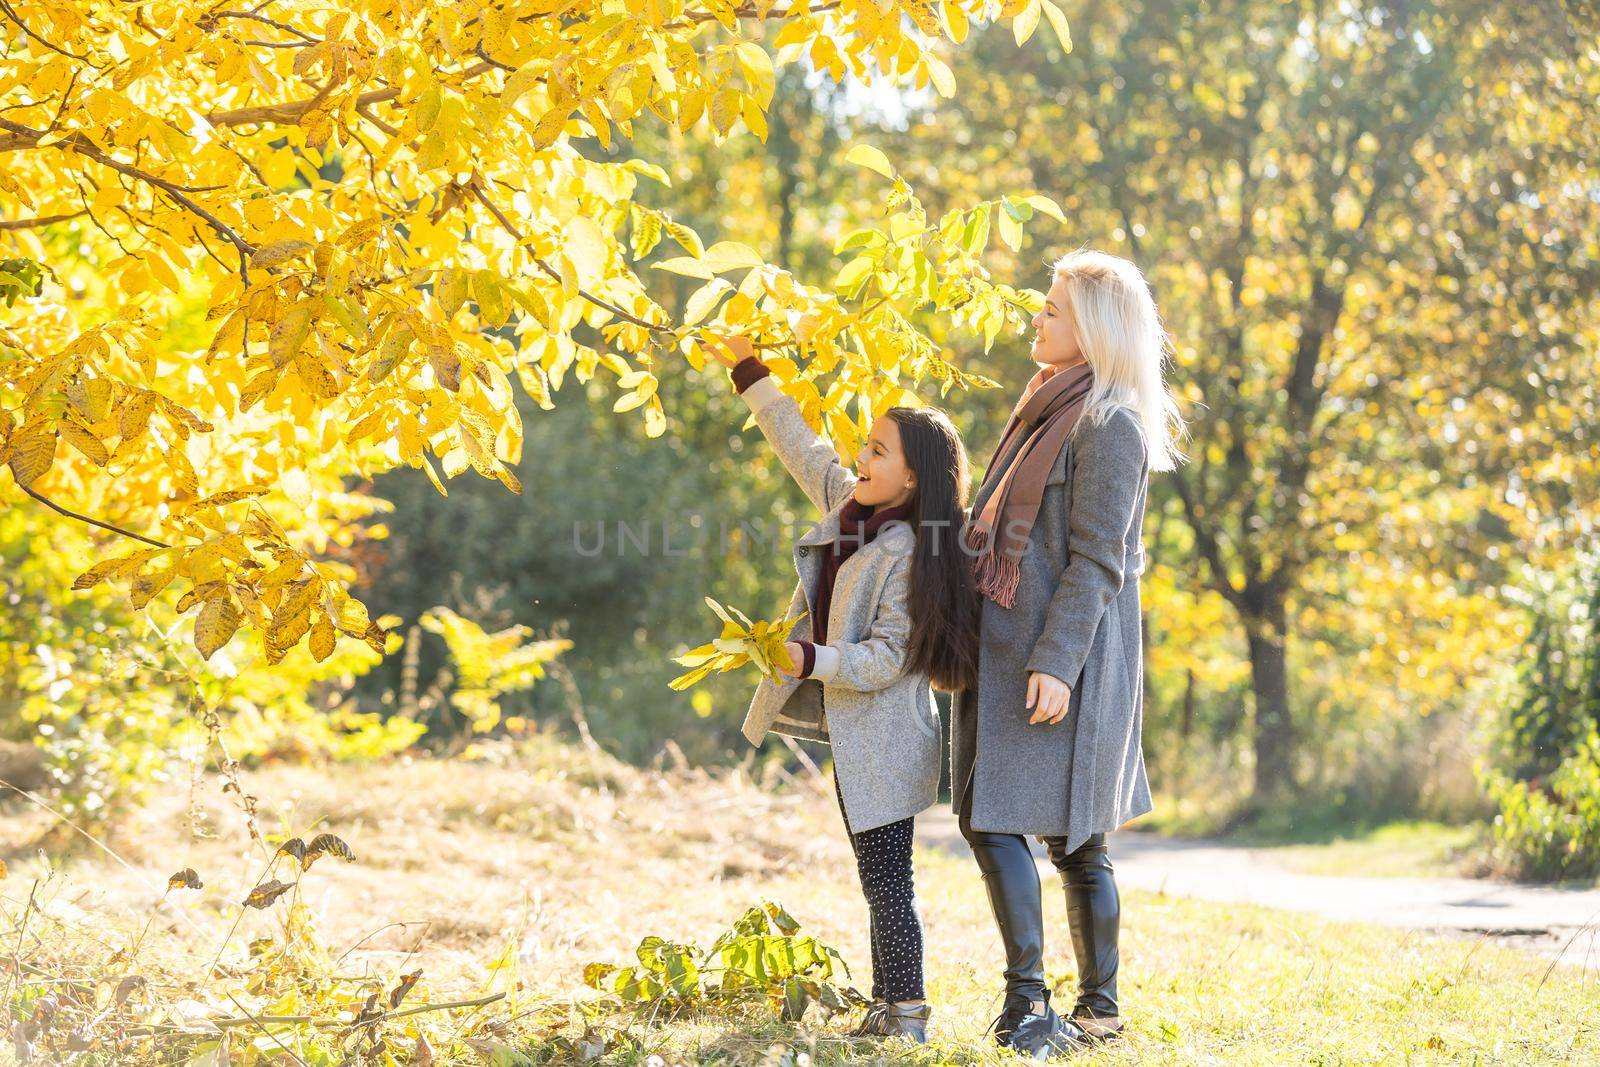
xmin=584 ymin=901 xmax=866 ymax=1022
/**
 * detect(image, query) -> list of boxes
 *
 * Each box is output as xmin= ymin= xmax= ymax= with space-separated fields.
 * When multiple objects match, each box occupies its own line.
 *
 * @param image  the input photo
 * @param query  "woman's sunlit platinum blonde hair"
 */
xmin=1053 ymin=248 xmax=1186 ymax=470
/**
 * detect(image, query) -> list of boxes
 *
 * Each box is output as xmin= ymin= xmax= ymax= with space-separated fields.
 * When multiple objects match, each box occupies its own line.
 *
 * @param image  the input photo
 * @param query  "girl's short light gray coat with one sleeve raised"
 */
xmin=741 ymin=378 xmax=941 ymax=833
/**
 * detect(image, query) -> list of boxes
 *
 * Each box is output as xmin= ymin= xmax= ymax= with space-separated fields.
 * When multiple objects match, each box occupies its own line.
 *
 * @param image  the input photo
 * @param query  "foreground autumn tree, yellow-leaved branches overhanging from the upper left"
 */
xmin=0 ymin=0 xmax=1067 ymax=662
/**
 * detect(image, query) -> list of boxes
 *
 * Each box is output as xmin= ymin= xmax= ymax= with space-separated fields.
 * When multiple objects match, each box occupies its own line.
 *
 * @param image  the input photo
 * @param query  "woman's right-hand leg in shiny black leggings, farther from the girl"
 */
xmin=1045 ymin=833 xmax=1122 ymax=1040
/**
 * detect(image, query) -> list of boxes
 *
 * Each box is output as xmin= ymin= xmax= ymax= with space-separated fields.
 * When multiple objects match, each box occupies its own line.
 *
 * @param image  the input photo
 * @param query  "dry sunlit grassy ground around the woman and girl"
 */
xmin=0 ymin=742 xmax=1600 ymax=1064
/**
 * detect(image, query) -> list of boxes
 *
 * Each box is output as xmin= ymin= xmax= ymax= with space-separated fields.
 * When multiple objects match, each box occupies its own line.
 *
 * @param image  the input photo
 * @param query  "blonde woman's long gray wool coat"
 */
xmin=950 ymin=408 xmax=1150 ymax=849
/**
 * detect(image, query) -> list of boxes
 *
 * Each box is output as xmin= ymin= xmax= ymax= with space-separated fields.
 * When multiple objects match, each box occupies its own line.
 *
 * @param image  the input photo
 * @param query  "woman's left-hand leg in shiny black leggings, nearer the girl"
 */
xmin=960 ymin=787 xmax=1048 ymax=1009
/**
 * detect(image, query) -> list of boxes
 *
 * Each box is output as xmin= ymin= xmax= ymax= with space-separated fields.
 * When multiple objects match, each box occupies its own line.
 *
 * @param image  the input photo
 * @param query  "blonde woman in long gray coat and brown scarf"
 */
xmin=950 ymin=251 xmax=1182 ymax=1056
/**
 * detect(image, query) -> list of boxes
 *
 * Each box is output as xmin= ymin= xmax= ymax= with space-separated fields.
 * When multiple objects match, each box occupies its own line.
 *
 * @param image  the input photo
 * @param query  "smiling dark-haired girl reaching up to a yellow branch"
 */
xmin=714 ymin=338 xmax=978 ymax=1043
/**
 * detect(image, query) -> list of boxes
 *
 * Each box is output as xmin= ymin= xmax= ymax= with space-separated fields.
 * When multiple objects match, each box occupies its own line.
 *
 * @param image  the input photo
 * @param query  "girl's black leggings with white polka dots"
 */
xmin=834 ymin=776 xmax=925 ymax=1003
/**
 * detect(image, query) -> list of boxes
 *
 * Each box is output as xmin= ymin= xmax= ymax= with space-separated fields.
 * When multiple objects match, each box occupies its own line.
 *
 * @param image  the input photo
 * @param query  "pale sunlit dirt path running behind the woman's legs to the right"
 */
xmin=917 ymin=811 xmax=1600 ymax=971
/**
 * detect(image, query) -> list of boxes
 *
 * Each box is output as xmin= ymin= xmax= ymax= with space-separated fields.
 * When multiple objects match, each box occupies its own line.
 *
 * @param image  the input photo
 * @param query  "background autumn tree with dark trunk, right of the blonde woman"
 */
xmin=915 ymin=0 xmax=1600 ymax=797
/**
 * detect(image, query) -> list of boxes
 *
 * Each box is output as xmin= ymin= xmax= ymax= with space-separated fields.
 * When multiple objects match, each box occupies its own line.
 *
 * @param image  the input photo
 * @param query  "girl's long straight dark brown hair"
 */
xmin=888 ymin=408 xmax=978 ymax=693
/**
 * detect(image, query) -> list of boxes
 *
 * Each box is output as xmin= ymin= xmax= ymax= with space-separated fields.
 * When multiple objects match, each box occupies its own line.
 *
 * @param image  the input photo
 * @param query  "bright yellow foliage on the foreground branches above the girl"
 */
xmin=0 ymin=0 xmax=1068 ymax=671
